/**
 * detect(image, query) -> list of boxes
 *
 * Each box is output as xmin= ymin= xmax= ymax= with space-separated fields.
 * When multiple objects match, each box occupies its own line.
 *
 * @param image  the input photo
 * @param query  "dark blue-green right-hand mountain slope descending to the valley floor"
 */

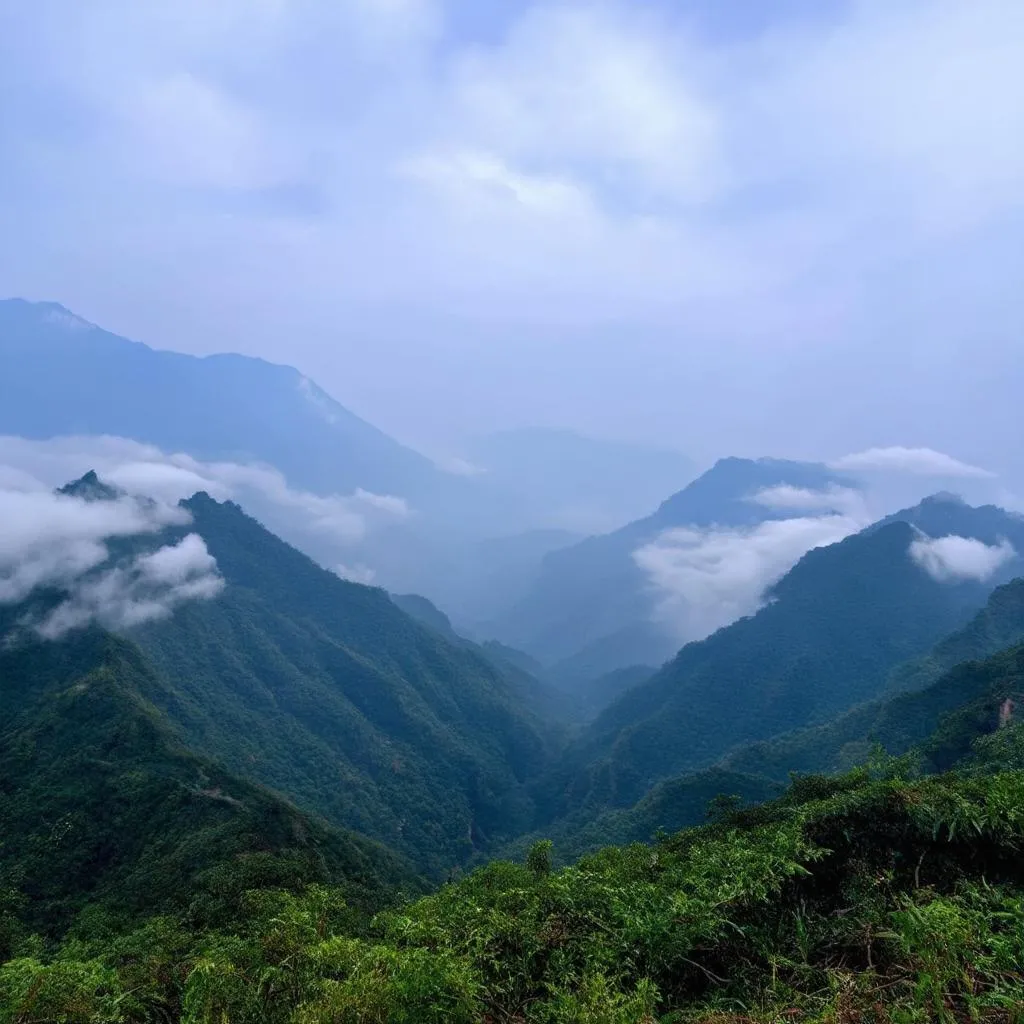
xmin=555 ymin=502 xmax=1024 ymax=816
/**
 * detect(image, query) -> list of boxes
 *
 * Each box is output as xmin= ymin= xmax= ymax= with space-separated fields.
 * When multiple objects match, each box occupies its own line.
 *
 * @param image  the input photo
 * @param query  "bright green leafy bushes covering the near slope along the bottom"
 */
xmin=0 ymin=749 xmax=1024 ymax=1024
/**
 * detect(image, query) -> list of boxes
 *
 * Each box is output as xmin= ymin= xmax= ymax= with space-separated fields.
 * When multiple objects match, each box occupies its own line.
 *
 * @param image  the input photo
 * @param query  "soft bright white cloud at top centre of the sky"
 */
xmin=449 ymin=3 xmax=724 ymax=201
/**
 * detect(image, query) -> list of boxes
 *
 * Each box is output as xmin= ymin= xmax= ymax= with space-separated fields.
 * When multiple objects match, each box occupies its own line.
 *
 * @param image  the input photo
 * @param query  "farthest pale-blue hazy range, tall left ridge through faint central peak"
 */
xmin=0 ymin=299 xmax=690 ymax=623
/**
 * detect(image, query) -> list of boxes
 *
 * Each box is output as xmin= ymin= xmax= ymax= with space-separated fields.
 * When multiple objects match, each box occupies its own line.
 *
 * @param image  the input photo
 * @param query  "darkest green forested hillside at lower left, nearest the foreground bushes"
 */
xmin=0 ymin=614 xmax=419 ymax=942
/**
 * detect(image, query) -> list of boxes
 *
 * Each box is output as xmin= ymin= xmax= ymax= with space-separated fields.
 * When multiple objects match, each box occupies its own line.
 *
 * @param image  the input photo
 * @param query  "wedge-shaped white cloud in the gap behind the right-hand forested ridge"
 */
xmin=633 ymin=515 xmax=864 ymax=643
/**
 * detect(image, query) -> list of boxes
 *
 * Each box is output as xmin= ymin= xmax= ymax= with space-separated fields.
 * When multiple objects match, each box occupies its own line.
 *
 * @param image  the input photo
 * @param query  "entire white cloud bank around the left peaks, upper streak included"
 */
xmin=0 ymin=436 xmax=413 ymax=638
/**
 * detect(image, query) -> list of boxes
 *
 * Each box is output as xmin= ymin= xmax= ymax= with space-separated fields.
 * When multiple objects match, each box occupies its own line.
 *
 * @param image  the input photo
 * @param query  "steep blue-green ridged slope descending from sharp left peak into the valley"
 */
xmin=125 ymin=495 xmax=551 ymax=873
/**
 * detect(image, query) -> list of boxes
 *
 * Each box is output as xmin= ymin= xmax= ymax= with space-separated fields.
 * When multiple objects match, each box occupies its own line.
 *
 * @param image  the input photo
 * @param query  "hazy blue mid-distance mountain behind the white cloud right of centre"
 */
xmin=488 ymin=459 xmax=849 ymax=690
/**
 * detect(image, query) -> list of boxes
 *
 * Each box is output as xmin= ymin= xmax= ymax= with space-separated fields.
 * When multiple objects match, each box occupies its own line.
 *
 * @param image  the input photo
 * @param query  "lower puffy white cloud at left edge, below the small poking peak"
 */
xmin=0 ymin=481 xmax=223 ymax=640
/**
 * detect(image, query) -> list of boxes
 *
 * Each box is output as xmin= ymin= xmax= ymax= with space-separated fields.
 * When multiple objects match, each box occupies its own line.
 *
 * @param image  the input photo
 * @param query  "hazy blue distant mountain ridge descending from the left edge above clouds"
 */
xmin=0 ymin=299 xmax=444 ymax=501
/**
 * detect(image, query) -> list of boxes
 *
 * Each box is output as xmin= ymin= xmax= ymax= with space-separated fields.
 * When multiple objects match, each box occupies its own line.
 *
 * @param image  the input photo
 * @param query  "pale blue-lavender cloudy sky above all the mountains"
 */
xmin=0 ymin=0 xmax=1024 ymax=471
